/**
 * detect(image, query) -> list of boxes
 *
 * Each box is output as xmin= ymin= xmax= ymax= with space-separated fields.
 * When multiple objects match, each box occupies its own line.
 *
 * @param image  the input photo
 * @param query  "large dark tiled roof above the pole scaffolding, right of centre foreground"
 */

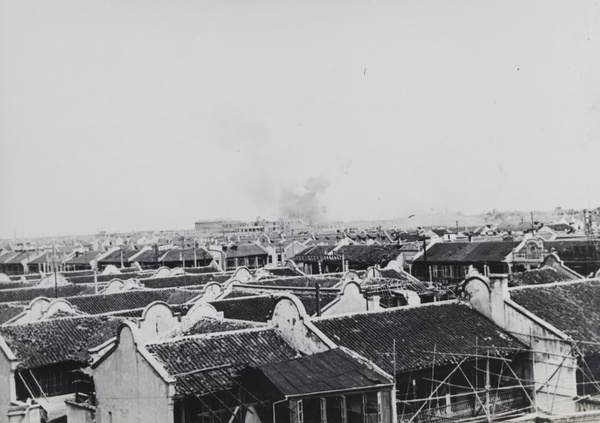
xmin=313 ymin=302 xmax=525 ymax=373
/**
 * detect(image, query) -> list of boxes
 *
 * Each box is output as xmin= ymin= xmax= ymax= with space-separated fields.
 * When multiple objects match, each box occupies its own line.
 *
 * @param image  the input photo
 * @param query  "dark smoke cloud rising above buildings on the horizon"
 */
xmin=280 ymin=176 xmax=329 ymax=224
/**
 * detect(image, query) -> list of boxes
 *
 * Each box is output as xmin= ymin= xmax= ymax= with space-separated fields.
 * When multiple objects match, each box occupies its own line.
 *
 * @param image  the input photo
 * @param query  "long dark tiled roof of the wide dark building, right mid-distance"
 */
xmin=415 ymin=241 xmax=519 ymax=263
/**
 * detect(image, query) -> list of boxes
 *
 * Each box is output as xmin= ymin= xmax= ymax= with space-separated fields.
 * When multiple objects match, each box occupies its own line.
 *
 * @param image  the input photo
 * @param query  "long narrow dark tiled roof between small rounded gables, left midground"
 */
xmin=66 ymin=289 xmax=202 ymax=314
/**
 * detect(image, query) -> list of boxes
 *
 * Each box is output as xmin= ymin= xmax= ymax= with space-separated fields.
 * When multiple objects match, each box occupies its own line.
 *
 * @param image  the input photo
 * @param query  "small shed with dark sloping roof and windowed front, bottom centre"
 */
xmin=242 ymin=348 xmax=395 ymax=423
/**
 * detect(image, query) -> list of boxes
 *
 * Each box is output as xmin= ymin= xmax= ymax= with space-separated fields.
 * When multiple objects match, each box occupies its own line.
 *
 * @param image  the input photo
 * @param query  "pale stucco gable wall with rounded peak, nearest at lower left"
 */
xmin=94 ymin=327 xmax=173 ymax=423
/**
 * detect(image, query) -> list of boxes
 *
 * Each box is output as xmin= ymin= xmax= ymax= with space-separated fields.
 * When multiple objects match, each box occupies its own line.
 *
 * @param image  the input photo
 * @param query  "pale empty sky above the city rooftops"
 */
xmin=0 ymin=0 xmax=600 ymax=238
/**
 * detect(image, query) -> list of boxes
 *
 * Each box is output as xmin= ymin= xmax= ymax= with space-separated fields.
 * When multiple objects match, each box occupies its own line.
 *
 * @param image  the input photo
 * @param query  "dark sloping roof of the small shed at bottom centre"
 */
xmin=258 ymin=348 xmax=392 ymax=396
